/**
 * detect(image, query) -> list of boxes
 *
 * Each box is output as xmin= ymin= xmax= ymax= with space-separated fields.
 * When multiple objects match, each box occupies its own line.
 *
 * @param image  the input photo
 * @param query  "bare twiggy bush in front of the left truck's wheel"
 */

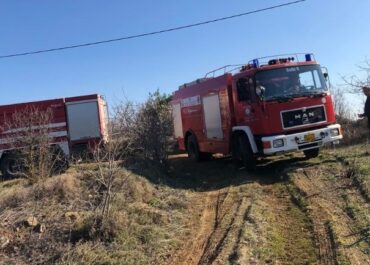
xmin=1 ymin=107 xmax=67 ymax=183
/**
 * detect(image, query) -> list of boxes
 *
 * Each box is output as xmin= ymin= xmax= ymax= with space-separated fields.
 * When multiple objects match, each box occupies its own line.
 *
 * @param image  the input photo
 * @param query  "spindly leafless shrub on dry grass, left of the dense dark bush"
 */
xmin=81 ymin=121 xmax=131 ymax=237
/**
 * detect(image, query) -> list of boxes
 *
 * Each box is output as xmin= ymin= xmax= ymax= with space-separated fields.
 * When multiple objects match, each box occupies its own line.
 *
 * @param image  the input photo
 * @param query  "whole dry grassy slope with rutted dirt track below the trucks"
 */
xmin=0 ymin=144 xmax=370 ymax=264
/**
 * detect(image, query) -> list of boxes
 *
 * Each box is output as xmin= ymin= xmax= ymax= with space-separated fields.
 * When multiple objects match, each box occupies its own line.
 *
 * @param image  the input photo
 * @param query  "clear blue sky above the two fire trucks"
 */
xmin=0 ymin=0 xmax=370 ymax=111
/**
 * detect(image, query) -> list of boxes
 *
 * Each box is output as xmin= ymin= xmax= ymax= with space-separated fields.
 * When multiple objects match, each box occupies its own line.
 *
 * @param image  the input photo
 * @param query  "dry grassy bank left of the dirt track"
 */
xmin=0 ymin=161 xmax=189 ymax=264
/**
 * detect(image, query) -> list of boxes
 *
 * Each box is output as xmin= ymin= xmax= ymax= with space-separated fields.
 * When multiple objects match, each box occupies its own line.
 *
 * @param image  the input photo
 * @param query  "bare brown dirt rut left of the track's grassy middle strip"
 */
xmin=167 ymin=177 xmax=249 ymax=265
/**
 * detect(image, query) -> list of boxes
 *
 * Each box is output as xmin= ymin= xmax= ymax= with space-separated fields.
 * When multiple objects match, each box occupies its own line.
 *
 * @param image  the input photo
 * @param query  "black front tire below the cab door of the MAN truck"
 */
xmin=233 ymin=134 xmax=256 ymax=171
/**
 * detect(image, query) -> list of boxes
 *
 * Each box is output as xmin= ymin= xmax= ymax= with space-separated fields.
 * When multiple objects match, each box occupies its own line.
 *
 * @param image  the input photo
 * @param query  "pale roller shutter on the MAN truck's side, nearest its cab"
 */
xmin=203 ymin=95 xmax=223 ymax=139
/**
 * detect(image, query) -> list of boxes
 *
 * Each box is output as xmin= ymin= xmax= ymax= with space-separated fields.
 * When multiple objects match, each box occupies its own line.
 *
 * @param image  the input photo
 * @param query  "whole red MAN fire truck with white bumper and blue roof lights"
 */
xmin=172 ymin=54 xmax=342 ymax=168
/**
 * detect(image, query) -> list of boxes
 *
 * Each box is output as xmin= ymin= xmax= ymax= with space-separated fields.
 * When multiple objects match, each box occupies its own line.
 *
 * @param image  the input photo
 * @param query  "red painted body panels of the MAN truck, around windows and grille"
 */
xmin=172 ymin=61 xmax=336 ymax=154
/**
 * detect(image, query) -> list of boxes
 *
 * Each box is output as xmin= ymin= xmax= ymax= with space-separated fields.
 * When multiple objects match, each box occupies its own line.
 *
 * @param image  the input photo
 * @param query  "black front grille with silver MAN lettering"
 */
xmin=281 ymin=106 xmax=326 ymax=129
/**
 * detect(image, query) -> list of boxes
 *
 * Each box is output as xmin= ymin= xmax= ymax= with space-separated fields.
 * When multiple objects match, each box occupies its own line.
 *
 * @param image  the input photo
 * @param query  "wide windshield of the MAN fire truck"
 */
xmin=256 ymin=65 xmax=328 ymax=100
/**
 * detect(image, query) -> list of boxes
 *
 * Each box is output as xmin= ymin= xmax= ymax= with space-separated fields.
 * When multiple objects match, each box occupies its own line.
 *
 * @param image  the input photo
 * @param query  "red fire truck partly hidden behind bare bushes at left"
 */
xmin=0 ymin=94 xmax=108 ymax=177
